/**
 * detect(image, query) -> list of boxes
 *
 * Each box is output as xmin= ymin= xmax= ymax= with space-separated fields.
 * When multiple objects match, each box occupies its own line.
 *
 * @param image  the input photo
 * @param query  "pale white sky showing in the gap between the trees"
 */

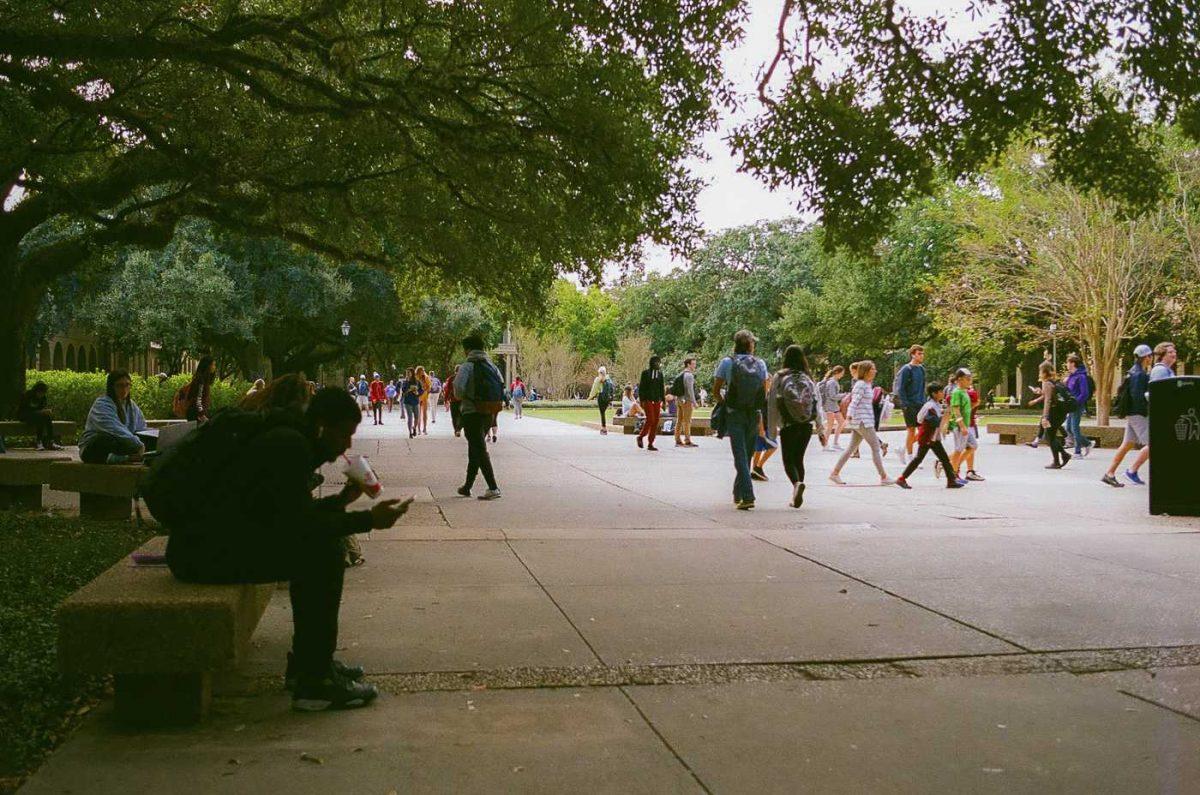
xmin=646 ymin=0 xmax=978 ymax=273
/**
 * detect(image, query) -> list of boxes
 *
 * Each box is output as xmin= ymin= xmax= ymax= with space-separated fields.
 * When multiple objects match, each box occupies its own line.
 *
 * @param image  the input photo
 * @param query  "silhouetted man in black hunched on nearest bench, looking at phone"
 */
xmin=167 ymin=389 xmax=412 ymax=712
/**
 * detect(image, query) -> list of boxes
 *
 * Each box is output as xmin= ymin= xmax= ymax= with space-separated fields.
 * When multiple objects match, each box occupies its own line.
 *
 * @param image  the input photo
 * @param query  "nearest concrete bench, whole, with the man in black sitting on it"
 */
xmin=58 ymin=536 xmax=275 ymax=725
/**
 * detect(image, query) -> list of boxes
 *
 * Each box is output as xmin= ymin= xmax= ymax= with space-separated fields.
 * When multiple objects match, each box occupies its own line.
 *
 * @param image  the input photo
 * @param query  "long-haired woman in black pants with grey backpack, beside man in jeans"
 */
xmin=767 ymin=345 xmax=823 ymax=508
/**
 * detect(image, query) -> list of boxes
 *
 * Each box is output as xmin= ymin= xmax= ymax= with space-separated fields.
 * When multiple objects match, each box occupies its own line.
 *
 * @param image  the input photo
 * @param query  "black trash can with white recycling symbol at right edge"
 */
xmin=1150 ymin=376 xmax=1200 ymax=516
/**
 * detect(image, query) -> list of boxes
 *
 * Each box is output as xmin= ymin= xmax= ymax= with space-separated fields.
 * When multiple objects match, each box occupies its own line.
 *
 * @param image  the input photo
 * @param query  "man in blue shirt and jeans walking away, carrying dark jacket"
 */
xmin=713 ymin=329 xmax=767 ymax=510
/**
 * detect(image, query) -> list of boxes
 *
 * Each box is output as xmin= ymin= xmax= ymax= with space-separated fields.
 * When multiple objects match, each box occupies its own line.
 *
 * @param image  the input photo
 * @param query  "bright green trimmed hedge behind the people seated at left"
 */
xmin=25 ymin=370 xmax=250 ymax=429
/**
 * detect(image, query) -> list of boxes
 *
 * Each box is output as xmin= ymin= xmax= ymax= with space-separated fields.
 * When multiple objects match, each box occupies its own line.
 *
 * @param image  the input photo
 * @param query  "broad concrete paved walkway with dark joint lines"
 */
xmin=26 ymin=416 xmax=1200 ymax=794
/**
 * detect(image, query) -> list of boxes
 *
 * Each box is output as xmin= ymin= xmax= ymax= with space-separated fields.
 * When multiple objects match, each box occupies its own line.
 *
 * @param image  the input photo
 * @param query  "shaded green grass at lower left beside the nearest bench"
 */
xmin=0 ymin=510 xmax=151 ymax=793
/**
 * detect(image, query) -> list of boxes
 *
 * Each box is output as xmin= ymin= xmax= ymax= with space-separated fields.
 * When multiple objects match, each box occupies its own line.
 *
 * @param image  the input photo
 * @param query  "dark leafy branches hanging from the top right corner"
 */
xmin=731 ymin=0 xmax=1200 ymax=250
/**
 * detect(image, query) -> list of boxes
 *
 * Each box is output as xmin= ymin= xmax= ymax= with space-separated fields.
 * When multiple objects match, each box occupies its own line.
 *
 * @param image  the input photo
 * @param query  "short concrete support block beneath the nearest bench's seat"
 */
xmin=113 ymin=673 xmax=212 ymax=727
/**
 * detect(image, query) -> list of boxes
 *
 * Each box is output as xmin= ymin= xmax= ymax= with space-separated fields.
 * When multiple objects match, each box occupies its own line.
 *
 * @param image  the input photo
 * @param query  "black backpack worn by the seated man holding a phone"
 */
xmin=138 ymin=408 xmax=280 ymax=528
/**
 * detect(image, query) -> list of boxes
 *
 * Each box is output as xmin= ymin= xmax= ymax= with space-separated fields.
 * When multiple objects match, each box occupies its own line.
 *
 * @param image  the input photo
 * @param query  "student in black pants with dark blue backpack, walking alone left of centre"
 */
xmin=454 ymin=334 xmax=504 ymax=500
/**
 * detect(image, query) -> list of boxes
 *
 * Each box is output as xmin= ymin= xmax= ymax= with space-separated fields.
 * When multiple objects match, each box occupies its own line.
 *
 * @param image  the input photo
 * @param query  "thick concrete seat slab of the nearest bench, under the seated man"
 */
xmin=58 ymin=536 xmax=275 ymax=674
